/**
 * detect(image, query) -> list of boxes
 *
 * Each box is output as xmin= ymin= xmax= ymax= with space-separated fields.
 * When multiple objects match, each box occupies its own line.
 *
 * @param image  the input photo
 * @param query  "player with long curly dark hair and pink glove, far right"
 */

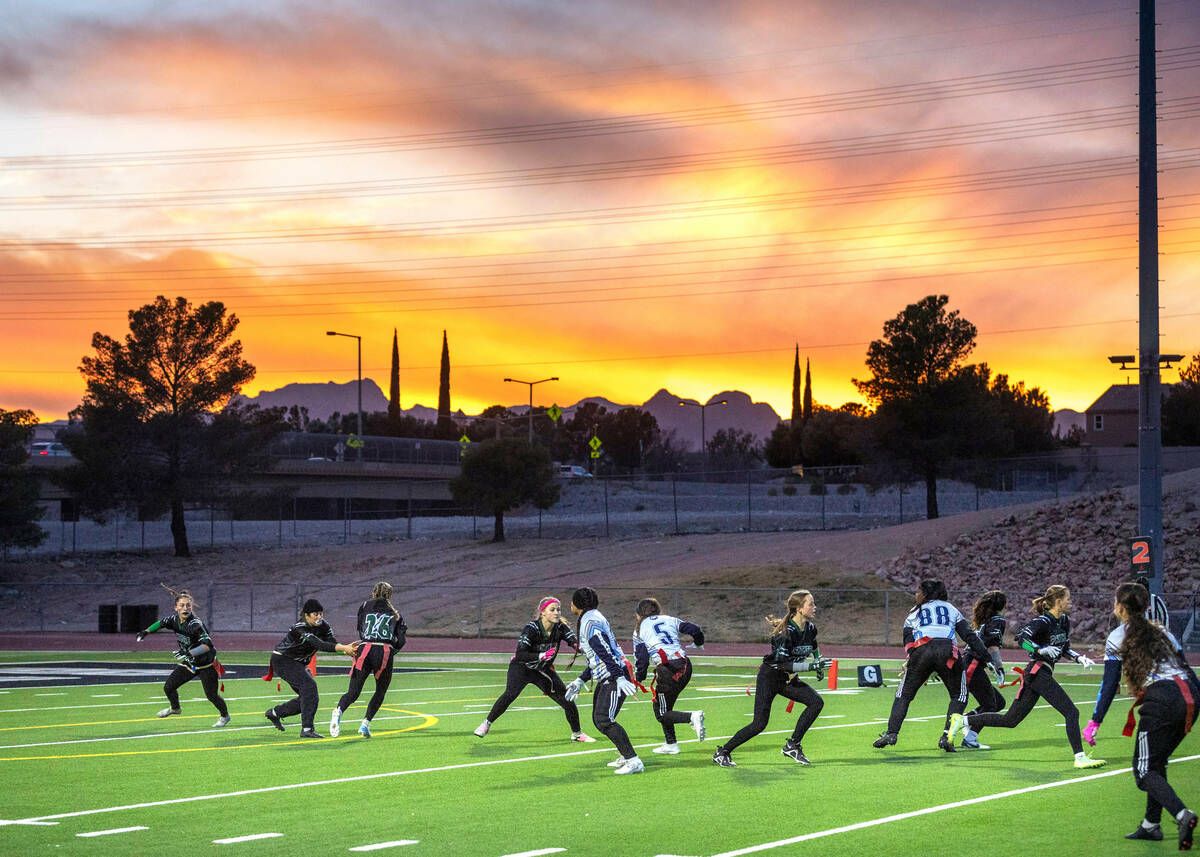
xmin=1084 ymin=583 xmax=1200 ymax=851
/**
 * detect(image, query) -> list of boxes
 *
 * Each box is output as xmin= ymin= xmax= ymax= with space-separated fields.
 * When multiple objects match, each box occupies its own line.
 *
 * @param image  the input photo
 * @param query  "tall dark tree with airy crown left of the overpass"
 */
xmin=64 ymin=295 xmax=254 ymax=557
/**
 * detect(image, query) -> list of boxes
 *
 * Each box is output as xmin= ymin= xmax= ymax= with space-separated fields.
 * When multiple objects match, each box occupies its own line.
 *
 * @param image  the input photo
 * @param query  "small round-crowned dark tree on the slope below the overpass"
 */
xmin=450 ymin=437 xmax=562 ymax=541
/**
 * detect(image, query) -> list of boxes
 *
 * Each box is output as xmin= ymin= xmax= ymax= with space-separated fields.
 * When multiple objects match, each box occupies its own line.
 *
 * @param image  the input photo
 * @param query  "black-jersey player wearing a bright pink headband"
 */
xmin=475 ymin=597 xmax=595 ymax=744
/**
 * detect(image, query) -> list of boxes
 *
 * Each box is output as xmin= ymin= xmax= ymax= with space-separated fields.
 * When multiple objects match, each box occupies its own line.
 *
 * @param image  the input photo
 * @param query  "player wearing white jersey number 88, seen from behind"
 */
xmin=874 ymin=580 xmax=994 ymax=753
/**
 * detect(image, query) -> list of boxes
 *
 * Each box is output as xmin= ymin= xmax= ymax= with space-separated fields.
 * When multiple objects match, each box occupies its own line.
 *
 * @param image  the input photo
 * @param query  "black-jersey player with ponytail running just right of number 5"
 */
xmin=713 ymin=589 xmax=833 ymax=768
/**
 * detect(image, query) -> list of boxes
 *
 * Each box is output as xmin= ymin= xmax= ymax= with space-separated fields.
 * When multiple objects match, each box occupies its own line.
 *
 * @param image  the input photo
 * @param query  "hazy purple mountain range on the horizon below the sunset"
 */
xmin=241 ymin=378 xmax=780 ymax=449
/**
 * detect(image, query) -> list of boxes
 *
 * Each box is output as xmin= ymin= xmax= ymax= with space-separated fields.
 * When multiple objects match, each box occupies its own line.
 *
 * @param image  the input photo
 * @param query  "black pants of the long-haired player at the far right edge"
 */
xmin=1133 ymin=678 xmax=1188 ymax=823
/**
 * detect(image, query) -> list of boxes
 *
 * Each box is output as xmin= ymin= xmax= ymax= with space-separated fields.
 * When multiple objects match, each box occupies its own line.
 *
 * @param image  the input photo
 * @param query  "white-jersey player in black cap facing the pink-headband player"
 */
xmin=566 ymin=587 xmax=646 ymax=774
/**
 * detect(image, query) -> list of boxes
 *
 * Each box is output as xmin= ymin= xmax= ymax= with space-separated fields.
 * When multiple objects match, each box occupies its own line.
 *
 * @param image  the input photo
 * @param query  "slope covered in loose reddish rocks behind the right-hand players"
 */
xmin=876 ymin=471 xmax=1200 ymax=640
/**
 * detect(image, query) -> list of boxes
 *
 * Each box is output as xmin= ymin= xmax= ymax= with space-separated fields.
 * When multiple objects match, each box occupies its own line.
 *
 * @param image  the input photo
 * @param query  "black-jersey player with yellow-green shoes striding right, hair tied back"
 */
xmin=950 ymin=585 xmax=1104 ymax=768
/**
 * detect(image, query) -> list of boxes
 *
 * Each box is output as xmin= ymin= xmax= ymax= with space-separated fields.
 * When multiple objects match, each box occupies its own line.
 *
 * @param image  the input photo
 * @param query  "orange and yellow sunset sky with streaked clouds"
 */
xmin=0 ymin=0 xmax=1200 ymax=419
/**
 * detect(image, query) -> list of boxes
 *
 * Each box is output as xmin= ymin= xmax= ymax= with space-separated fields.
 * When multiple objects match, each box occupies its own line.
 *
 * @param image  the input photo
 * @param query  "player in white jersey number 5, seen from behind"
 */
xmin=634 ymin=598 xmax=704 ymax=755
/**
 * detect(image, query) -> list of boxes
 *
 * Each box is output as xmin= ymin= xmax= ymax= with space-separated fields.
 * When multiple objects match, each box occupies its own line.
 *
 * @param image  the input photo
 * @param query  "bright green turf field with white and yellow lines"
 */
xmin=0 ymin=652 xmax=1200 ymax=857
